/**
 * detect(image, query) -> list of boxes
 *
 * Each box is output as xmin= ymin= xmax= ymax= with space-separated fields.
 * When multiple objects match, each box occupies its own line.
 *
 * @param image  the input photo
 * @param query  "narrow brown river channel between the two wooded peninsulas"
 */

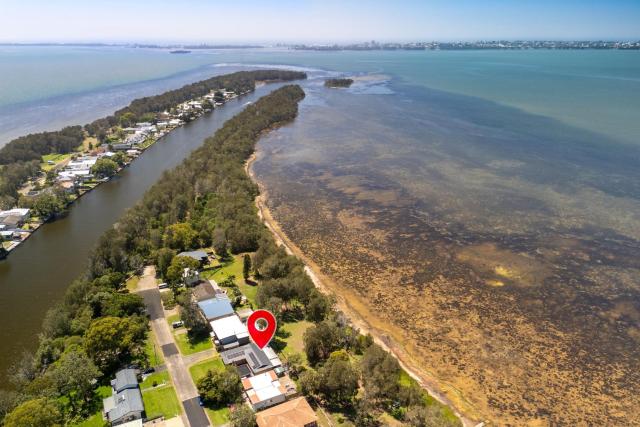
xmin=0 ymin=84 xmax=280 ymax=388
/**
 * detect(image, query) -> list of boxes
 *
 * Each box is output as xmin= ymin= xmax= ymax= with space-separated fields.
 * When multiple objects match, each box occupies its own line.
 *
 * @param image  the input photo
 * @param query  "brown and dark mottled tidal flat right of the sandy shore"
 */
xmin=253 ymin=81 xmax=640 ymax=425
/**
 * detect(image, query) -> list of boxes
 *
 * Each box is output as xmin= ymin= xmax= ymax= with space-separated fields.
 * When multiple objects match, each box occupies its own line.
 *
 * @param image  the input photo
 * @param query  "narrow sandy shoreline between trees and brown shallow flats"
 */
xmin=245 ymin=153 xmax=478 ymax=427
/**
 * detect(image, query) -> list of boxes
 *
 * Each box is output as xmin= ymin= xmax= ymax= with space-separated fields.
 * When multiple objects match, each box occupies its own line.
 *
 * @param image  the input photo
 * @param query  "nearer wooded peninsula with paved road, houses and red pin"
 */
xmin=4 ymin=85 xmax=460 ymax=426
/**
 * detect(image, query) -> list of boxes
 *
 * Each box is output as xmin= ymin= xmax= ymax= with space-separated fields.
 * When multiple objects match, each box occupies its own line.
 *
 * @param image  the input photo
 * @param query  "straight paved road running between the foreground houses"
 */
xmin=138 ymin=267 xmax=209 ymax=427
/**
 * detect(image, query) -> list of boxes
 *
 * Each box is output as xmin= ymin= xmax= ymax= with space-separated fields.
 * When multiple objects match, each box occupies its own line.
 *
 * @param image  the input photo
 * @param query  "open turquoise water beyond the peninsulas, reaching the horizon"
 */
xmin=0 ymin=47 xmax=640 ymax=143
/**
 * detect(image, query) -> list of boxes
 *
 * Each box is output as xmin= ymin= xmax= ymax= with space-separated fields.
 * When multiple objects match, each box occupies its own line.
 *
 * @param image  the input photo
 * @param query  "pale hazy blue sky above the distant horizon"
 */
xmin=0 ymin=0 xmax=640 ymax=42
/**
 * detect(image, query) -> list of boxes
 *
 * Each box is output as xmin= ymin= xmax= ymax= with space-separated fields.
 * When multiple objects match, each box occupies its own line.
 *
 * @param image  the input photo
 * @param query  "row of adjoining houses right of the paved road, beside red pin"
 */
xmin=188 ymin=264 xmax=318 ymax=427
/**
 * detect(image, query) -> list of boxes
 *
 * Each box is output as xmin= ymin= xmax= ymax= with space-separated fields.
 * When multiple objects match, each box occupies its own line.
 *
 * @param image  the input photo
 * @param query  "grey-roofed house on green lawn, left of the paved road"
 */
xmin=102 ymin=369 xmax=144 ymax=426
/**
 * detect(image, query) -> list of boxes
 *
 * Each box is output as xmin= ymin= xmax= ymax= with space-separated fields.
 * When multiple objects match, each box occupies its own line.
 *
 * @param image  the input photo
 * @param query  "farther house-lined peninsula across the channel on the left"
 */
xmin=0 ymin=70 xmax=306 ymax=259
